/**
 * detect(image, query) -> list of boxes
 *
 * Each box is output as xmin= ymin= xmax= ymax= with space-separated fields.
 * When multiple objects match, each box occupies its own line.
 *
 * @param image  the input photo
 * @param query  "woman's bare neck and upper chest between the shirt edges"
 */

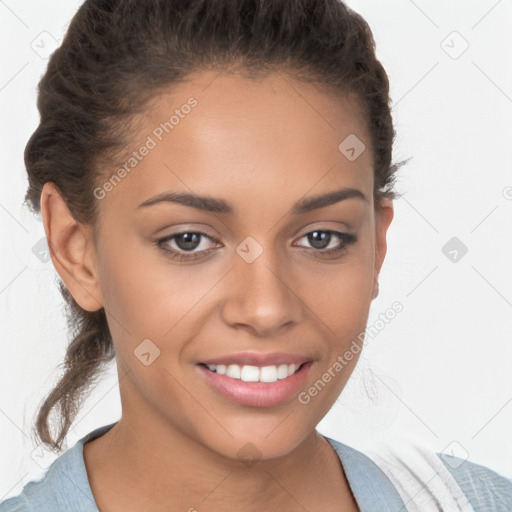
xmin=84 ymin=415 xmax=357 ymax=512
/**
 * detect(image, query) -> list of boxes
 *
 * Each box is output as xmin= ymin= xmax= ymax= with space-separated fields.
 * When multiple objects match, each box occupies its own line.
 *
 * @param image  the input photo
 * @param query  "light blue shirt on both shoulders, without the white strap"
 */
xmin=0 ymin=423 xmax=512 ymax=512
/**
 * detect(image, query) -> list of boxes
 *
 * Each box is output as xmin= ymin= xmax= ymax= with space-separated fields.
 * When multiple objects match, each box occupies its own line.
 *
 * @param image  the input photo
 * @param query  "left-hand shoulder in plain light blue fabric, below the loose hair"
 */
xmin=0 ymin=424 xmax=113 ymax=512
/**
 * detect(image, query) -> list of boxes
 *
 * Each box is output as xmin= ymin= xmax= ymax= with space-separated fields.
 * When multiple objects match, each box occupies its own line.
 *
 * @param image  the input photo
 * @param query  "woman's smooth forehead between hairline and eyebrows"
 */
xmin=98 ymin=71 xmax=373 ymax=216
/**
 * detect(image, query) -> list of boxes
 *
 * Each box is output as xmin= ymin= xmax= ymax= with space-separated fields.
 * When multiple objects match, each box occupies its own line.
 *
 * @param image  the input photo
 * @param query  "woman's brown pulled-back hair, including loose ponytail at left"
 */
xmin=25 ymin=0 xmax=403 ymax=450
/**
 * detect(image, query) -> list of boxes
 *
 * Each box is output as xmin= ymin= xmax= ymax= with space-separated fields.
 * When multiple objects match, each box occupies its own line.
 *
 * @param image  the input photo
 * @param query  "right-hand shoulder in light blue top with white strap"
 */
xmin=326 ymin=436 xmax=512 ymax=512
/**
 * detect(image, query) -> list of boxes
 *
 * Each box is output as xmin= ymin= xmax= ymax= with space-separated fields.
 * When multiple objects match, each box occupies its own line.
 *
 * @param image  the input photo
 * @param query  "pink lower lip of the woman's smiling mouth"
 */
xmin=197 ymin=361 xmax=313 ymax=407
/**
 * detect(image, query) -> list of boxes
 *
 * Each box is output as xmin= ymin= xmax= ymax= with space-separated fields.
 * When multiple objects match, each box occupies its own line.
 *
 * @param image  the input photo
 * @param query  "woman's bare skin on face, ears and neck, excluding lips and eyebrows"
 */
xmin=41 ymin=72 xmax=393 ymax=512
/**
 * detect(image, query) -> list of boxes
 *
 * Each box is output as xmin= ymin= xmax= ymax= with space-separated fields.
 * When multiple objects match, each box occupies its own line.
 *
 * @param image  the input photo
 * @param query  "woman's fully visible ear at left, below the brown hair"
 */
xmin=41 ymin=182 xmax=103 ymax=311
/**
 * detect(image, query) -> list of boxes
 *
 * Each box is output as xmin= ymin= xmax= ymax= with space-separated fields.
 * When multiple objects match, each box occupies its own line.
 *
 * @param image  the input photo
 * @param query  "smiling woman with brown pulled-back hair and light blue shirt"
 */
xmin=0 ymin=0 xmax=512 ymax=512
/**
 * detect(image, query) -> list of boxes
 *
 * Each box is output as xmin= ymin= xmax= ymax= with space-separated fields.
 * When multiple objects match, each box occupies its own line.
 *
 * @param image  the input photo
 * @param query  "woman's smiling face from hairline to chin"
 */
xmin=68 ymin=72 xmax=392 ymax=458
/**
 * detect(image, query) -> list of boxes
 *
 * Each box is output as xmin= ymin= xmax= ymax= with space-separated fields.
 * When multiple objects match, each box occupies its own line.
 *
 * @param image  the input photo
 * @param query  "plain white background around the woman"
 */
xmin=0 ymin=0 xmax=512 ymax=501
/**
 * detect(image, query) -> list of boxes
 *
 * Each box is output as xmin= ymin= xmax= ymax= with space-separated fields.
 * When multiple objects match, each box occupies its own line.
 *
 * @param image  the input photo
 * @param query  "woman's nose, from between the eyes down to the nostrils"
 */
xmin=224 ymin=237 xmax=300 ymax=334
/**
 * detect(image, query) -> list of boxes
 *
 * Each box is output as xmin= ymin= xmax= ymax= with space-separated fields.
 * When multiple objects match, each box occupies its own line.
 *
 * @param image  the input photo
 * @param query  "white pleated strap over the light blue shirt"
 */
xmin=364 ymin=442 xmax=475 ymax=512
